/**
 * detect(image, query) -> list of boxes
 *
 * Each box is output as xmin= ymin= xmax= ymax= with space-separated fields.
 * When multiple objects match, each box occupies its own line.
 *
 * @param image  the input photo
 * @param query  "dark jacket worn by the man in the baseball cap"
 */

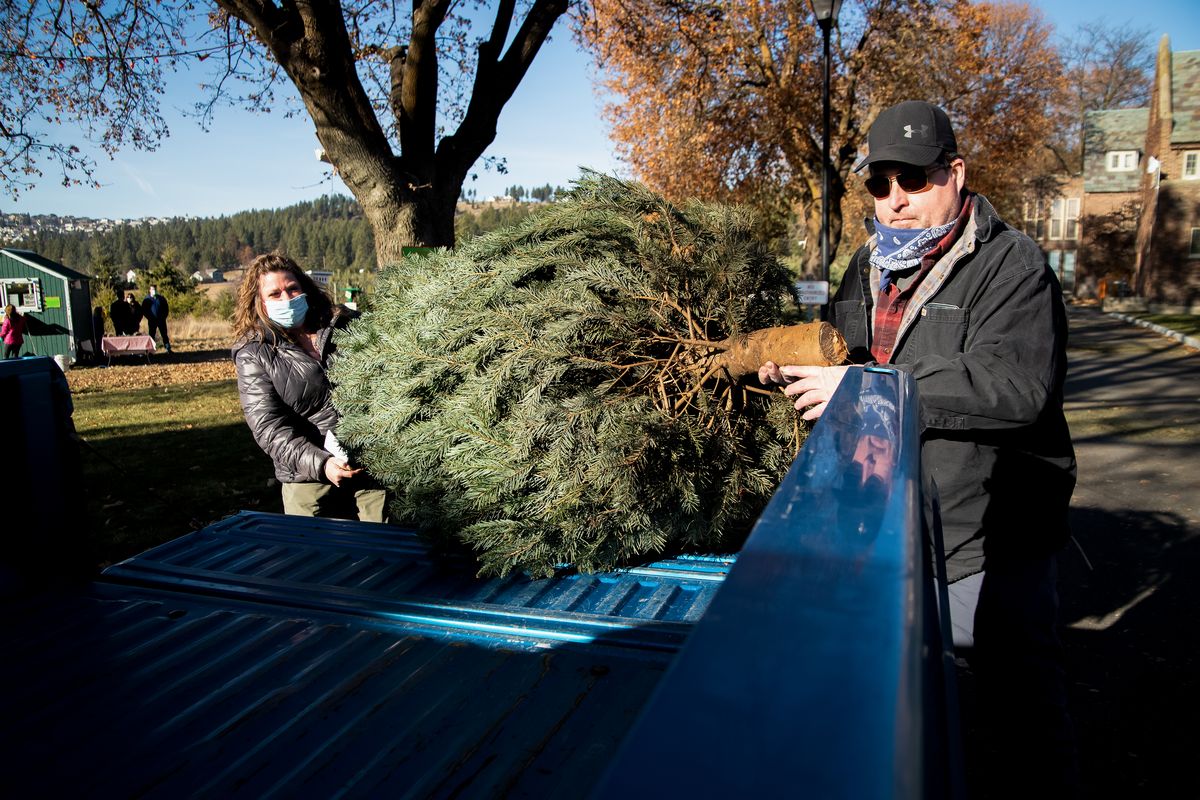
xmin=830 ymin=196 xmax=1075 ymax=582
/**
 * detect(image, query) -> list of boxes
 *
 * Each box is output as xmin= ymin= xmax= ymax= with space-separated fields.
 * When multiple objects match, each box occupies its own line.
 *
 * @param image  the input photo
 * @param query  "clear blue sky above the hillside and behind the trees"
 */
xmin=9 ymin=0 xmax=1200 ymax=218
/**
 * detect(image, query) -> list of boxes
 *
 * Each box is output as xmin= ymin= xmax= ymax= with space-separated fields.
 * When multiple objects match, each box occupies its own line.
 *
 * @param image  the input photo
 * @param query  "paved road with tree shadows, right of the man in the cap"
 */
xmin=1060 ymin=308 xmax=1200 ymax=799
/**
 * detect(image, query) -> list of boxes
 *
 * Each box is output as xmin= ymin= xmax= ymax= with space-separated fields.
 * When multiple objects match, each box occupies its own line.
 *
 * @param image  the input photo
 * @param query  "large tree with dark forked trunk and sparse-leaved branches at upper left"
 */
xmin=0 ymin=0 xmax=570 ymax=256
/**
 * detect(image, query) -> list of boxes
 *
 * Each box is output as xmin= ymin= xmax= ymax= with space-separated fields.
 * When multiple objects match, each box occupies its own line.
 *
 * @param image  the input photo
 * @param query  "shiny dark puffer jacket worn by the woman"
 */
xmin=233 ymin=307 xmax=356 ymax=483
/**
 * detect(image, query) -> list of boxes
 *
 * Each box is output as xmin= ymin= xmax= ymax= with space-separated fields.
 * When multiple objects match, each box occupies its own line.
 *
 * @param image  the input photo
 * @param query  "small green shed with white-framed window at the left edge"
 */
xmin=0 ymin=248 xmax=94 ymax=363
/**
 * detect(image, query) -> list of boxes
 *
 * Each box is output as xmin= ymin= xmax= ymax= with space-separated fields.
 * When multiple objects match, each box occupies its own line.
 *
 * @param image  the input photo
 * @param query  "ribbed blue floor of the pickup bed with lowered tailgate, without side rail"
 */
xmin=0 ymin=513 xmax=730 ymax=798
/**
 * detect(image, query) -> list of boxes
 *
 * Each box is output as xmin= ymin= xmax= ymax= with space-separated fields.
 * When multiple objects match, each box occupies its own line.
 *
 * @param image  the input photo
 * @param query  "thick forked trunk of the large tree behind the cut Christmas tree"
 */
xmin=216 ymin=0 xmax=568 ymax=265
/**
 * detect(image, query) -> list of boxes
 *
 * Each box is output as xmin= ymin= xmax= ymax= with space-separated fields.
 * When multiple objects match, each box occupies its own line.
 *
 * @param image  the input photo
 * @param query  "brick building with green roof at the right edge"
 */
xmin=1025 ymin=36 xmax=1200 ymax=309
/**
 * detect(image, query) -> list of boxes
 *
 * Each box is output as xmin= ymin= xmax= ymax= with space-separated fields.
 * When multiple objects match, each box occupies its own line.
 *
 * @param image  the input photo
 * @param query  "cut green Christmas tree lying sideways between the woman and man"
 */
xmin=331 ymin=173 xmax=846 ymax=576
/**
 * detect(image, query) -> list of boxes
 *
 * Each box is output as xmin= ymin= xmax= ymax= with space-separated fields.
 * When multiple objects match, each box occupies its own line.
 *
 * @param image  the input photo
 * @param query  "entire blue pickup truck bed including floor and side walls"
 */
xmin=0 ymin=359 xmax=961 ymax=800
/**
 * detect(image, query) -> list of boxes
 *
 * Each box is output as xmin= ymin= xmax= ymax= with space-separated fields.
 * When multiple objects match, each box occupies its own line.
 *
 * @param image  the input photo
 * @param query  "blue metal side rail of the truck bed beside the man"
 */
xmin=596 ymin=367 xmax=961 ymax=798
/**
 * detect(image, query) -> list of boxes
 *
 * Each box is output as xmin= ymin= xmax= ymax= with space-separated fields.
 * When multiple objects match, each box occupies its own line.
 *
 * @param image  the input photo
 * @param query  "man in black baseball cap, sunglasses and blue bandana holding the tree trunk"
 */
xmin=758 ymin=101 xmax=1076 ymax=796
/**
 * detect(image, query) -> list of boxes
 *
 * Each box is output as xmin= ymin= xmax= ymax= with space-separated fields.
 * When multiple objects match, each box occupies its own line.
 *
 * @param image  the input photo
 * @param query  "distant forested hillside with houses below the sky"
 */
xmin=0 ymin=196 xmax=549 ymax=275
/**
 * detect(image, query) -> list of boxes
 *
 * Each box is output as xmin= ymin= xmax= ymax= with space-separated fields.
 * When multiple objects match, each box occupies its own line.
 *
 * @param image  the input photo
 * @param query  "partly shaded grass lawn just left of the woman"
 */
xmin=73 ymin=380 xmax=282 ymax=566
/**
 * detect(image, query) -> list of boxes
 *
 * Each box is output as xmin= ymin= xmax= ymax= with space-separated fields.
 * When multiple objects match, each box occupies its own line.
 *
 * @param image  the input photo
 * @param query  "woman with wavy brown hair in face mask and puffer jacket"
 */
xmin=233 ymin=253 xmax=385 ymax=522
